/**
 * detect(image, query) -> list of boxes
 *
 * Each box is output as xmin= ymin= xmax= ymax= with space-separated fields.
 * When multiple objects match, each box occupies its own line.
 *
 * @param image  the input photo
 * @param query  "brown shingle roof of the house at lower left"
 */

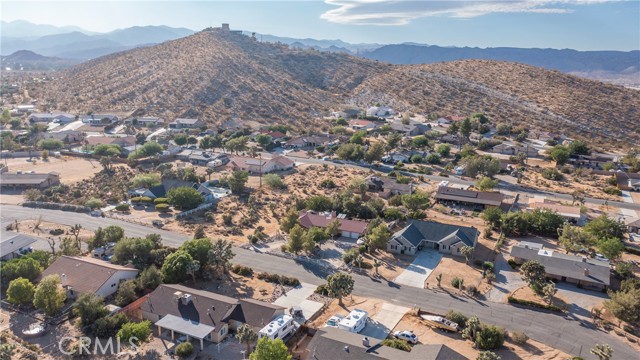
xmin=42 ymin=255 xmax=138 ymax=294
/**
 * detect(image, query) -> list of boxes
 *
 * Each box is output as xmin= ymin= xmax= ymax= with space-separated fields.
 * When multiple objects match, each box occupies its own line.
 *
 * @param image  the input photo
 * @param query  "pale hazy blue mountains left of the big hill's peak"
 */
xmin=0 ymin=23 xmax=193 ymax=60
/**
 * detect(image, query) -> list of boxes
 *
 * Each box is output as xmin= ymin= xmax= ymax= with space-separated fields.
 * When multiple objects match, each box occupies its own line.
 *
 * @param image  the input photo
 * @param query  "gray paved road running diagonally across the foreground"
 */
xmin=0 ymin=205 xmax=638 ymax=359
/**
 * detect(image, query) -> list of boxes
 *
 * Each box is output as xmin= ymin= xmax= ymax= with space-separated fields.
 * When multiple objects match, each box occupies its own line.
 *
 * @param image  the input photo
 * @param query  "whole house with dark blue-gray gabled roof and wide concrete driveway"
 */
xmin=387 ymin=220 xmax=480 ymax=256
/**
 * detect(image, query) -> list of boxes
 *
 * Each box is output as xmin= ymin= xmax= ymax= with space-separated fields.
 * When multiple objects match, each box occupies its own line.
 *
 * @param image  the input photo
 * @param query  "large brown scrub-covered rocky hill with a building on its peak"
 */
xmin=31 ymin=30 xmax=640 ymax=143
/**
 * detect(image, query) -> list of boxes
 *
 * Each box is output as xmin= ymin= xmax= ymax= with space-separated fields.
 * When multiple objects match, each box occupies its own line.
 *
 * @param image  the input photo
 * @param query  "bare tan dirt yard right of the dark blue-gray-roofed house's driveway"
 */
xmin=426 ymin=255 xmax=491 ymax=293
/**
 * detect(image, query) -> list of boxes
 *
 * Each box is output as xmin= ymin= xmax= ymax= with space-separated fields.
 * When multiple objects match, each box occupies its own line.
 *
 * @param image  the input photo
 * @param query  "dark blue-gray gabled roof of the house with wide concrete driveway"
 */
xmin=393 ymin=220 xmax=478 ymax=247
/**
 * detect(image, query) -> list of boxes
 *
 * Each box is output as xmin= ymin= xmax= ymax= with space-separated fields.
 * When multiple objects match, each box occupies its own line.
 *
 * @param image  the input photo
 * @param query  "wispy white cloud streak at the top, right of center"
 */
xmin=320 ymin=0 xmax=624 ymax=25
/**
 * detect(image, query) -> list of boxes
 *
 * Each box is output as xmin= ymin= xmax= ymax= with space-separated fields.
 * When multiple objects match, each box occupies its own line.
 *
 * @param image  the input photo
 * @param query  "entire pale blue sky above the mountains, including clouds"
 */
xmin=0 ymin=0 xmax=640 ymax=51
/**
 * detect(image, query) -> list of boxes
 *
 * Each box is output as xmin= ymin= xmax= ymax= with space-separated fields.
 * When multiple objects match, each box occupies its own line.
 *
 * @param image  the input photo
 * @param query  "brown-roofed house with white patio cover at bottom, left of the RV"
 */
xmin=140 ymin=284 xmax=285 ymax=350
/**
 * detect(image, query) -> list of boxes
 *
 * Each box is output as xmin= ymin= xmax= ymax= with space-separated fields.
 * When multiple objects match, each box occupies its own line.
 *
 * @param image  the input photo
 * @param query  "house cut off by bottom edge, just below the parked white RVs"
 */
xmin=307 ymin=327 xmax=466 ymax=360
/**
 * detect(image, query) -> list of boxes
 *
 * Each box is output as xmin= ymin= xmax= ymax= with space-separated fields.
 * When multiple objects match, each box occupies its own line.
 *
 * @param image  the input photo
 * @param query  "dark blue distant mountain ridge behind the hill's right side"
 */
xmin=360 ymin=44 xmax=640 ymax=84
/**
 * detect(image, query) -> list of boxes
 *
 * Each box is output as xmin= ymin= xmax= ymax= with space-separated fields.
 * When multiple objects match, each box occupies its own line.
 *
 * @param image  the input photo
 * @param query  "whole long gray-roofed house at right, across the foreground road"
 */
xmin=511 ymin=241 xmax=611 ymax=290
